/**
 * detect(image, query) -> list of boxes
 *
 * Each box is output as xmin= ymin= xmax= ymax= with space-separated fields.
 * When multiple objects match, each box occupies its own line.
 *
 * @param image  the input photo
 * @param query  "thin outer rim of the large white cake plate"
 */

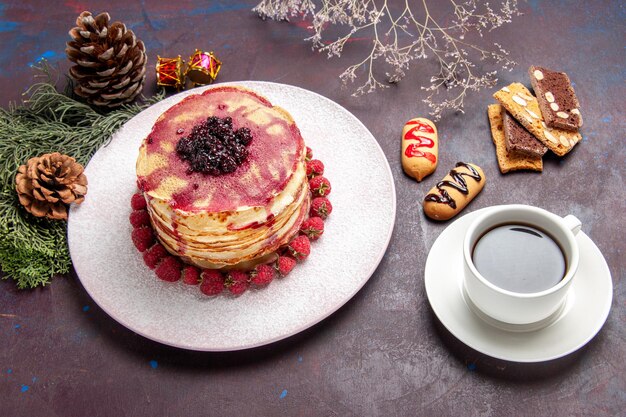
xmin=67 ymin=80 xmax=397 ymax=352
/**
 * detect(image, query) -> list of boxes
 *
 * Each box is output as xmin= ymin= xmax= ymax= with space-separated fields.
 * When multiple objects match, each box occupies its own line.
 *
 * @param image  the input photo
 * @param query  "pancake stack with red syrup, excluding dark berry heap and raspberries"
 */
xmin=137 ymin=86 xmax=310 ymax=269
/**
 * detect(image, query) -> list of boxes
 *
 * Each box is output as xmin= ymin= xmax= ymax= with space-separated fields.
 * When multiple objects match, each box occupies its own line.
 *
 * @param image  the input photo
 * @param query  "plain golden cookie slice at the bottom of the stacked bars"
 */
xmin=487 ymin=104 xmax=543 ymax=174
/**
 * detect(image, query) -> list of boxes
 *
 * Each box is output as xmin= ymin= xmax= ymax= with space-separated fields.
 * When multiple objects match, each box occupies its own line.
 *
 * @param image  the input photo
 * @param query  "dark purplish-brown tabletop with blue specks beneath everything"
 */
xmin=0 ymin=0 xmax=626 ymax=416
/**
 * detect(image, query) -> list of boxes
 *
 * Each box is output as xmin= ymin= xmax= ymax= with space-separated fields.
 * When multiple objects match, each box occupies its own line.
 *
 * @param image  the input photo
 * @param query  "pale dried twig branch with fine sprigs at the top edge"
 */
xmin=253 ymin=0 xmax=519 ymax=120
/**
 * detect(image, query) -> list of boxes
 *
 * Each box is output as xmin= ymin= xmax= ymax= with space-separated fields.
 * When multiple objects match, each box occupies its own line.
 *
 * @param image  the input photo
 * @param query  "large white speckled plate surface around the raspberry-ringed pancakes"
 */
xmin=68 ymin=81 xmax=396 ymax=351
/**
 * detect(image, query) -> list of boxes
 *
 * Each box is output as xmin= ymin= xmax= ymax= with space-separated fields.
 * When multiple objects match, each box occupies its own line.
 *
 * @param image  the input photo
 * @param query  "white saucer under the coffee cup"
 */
xmin=424 ymin=208 xmax=613 ymax=362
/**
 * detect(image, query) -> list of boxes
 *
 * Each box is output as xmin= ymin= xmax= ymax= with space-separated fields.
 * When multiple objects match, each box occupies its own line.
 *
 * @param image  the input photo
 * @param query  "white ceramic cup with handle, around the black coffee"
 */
xmin=463 ymin=204 xmax=581 ymax=330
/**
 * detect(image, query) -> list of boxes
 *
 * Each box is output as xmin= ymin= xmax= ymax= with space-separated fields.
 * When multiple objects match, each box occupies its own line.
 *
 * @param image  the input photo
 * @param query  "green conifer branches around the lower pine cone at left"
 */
xmin=0 ymin=62 xmax=164 ymax=288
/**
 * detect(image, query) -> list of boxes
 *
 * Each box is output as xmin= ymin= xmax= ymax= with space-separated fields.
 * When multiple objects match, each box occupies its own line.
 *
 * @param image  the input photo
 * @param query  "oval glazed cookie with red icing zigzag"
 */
xmin=402 ymin=117 xmax=439 ymax=181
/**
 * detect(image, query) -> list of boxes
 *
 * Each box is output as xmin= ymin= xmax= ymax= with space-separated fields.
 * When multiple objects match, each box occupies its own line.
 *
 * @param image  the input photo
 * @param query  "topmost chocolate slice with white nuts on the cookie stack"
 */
xmin=528 ymin=66 xmax=583 ymax=132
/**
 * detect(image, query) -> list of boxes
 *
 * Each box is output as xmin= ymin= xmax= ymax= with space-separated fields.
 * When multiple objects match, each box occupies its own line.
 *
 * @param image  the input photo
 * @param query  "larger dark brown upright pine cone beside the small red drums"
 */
xmin=65 ymin=11 xmax=147 ymax=107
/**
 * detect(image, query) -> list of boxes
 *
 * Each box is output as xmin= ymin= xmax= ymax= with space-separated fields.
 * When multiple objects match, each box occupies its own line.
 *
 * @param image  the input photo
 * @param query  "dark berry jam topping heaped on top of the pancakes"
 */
xmin=176 ymin=116 xmax=252 ymax=175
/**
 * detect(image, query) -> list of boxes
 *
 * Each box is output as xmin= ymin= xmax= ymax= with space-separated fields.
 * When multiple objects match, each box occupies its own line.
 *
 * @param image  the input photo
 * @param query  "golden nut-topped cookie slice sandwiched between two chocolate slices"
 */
xmin=493 ymin=83 xmax=581 ymax=156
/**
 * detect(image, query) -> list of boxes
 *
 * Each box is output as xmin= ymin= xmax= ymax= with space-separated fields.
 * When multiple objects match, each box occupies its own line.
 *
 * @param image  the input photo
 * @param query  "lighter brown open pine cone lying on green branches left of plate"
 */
xmin=15 ymin=152 xmax=87 ymax=219
